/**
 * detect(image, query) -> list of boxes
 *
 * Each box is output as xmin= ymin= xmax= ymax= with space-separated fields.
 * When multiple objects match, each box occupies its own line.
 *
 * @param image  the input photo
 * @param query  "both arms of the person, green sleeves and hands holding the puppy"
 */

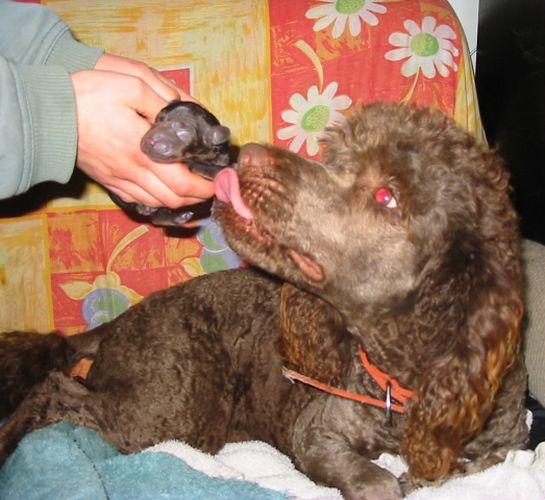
xmin=0 ymin=0 xmax=212 ymax=207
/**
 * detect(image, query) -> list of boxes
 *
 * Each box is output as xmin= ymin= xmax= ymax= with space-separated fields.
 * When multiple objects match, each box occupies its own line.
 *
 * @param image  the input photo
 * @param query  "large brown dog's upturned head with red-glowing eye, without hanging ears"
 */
xmin=215 ymin=104 xmax=516 ymax=316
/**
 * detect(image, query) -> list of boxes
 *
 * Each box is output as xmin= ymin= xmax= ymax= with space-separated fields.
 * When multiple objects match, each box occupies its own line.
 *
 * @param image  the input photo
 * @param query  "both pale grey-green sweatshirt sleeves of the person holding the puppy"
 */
xmin=0 ymin=0 xmax=103 ymax=198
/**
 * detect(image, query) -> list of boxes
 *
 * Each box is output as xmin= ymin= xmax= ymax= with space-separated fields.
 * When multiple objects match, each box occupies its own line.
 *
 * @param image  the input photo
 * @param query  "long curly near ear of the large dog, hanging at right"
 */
xmin=403 ymin=230 xmax=523 ymax=480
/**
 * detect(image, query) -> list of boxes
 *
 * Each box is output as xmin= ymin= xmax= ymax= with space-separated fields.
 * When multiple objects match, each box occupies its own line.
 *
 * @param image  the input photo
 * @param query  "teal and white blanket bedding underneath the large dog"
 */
xmin=0 ymin=423 xmax=545 ymax=500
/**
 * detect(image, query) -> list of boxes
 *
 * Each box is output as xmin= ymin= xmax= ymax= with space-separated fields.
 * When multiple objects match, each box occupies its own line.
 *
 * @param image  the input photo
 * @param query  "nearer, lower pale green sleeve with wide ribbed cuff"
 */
xmin=0 ymin=52 xmax=82 ymax=198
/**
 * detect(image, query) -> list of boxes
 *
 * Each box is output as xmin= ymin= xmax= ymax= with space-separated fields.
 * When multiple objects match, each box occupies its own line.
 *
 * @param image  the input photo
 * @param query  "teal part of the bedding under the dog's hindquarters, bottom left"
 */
xmin=0 ymin=423 xmax=286 ymax=500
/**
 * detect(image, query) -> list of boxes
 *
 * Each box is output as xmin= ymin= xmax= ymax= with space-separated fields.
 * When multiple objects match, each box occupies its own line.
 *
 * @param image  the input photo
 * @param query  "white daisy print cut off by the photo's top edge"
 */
xmin=306 ymin=0 xmax=387 ymax=38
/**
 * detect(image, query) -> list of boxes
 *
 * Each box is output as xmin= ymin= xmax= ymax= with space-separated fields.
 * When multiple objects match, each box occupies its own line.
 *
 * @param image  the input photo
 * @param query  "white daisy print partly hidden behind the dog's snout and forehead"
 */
xmin=276 ymin=82 xmax=352 ymax=156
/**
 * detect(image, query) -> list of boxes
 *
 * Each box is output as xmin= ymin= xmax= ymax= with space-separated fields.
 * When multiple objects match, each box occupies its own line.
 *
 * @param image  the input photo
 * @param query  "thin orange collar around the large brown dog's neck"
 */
xmin=282 ymin=347 xmax=414 ymax=419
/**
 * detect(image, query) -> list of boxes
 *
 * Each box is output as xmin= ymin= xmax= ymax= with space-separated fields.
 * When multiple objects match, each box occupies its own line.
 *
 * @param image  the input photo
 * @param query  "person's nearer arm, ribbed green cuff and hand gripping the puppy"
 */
xmin=0 ymin=50 xmax=212 ymax=207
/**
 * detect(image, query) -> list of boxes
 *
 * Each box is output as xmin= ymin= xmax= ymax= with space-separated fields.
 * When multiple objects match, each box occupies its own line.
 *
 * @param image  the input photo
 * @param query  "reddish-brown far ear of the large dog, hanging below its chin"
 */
xmin=278 ymin=283 xmax=352 ymax=384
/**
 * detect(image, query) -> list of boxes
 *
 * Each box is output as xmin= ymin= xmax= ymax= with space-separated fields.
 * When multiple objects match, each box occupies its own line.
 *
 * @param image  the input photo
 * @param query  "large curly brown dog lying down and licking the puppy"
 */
xmin=0 ymin=104 xmax=527 ymax=500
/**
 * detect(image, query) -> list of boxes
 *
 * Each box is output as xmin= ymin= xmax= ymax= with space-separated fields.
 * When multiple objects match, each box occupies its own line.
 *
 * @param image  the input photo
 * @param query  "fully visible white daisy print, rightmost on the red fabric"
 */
xmin=384 ymin=16 xmax=459 ymax=78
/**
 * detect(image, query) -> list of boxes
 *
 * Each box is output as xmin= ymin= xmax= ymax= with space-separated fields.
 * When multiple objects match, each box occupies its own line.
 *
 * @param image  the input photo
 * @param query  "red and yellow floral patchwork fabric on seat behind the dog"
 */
xmin=0 ymin=0 xmax=482 ymax=334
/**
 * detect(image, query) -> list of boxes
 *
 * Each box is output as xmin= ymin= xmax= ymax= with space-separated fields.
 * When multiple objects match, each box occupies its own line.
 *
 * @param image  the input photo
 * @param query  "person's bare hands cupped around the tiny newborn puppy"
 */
xmin=71 ymin=54 xmax=213 ymax=208
